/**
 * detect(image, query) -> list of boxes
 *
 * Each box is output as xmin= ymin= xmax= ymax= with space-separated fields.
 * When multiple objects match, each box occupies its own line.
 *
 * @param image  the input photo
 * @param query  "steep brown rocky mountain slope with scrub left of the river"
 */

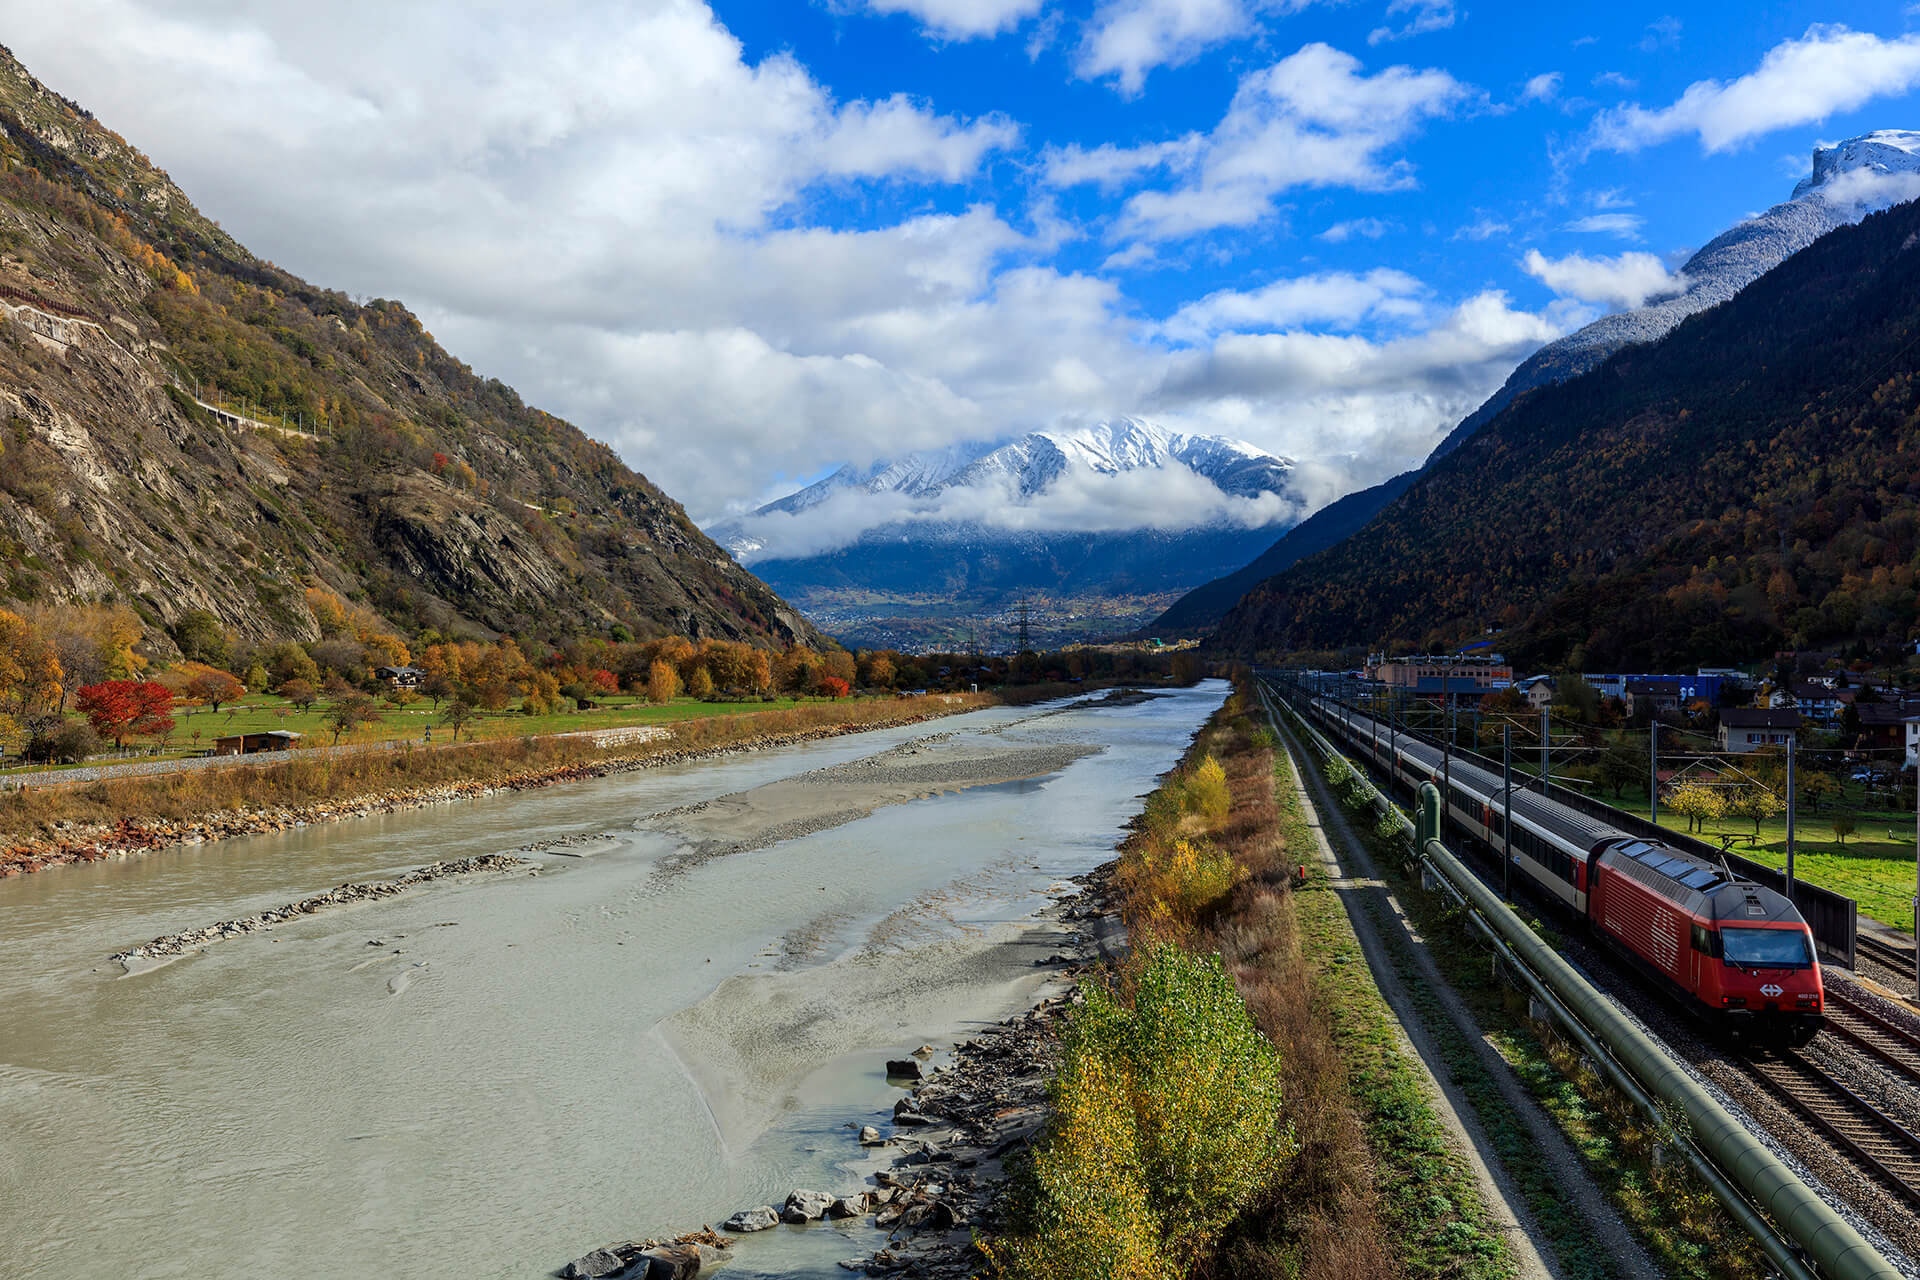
xmin=0 ymin=50 xmax=818 ymax=645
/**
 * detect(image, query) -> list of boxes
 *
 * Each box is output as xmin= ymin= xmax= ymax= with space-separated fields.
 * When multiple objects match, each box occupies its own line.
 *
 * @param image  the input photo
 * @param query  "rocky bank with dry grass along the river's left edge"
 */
xmin=0 ymin=699 xmax=972 ymax=879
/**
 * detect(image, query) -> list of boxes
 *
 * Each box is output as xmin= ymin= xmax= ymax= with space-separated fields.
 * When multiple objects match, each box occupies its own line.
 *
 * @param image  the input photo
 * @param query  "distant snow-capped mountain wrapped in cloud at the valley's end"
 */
xmin=710 ymin=418 xmax=1292 ymax=637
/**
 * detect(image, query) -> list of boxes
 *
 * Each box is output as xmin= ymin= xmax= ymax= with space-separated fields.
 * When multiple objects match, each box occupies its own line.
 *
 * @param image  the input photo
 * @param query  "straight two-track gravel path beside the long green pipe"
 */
xmin=1283 ymin=725 xmax=1661 ymax=1280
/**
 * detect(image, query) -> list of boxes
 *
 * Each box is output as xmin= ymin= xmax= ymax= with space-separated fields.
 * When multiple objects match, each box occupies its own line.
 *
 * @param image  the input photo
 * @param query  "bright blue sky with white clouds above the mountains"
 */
xmin=0 ymin=0 xmax=1920 ymax=533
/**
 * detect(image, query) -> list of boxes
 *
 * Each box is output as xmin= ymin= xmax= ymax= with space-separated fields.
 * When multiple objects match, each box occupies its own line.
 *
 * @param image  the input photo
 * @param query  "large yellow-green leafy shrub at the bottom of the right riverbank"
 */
xmin=993 ymin=940 xmax=1288 ymax=1280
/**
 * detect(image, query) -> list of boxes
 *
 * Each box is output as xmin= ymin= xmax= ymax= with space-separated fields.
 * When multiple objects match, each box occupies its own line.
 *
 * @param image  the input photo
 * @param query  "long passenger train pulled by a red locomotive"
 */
xmin=1315 ymin=699 xmax=1826 ymax=1046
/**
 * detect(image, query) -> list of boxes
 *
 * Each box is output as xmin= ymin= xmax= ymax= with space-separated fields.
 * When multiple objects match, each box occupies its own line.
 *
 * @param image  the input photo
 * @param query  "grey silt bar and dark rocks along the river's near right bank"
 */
xmin=563 ymin=864 xmax=1125 ymax=1280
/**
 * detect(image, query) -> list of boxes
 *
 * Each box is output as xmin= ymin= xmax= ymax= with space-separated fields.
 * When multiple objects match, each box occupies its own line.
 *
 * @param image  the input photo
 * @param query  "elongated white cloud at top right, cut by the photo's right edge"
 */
xmin=1590 ymin=25 xmax=1920 ymax=152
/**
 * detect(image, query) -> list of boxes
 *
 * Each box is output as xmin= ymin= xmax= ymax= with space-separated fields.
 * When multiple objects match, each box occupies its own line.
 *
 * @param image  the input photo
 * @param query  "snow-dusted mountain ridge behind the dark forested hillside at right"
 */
xmin=1154 ymin=129 xmax=1920 ymax=633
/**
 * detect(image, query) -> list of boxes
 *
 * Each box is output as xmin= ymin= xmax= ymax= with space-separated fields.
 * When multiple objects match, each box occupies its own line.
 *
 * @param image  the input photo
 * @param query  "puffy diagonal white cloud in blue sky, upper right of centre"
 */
xmin=1116 ymin=44 xmax=1467 ymax=240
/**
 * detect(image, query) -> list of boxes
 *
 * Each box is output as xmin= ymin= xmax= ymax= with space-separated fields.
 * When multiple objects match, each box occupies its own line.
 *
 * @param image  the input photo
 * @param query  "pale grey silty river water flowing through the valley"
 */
xmin=0 ymin=681 xmax=1225 ymax=1280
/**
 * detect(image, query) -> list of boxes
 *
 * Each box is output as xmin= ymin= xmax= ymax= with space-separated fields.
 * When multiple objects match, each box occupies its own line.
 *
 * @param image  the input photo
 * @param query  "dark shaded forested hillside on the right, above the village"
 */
xmin=1217 ymin=203 xmax=1920 ymax=670
